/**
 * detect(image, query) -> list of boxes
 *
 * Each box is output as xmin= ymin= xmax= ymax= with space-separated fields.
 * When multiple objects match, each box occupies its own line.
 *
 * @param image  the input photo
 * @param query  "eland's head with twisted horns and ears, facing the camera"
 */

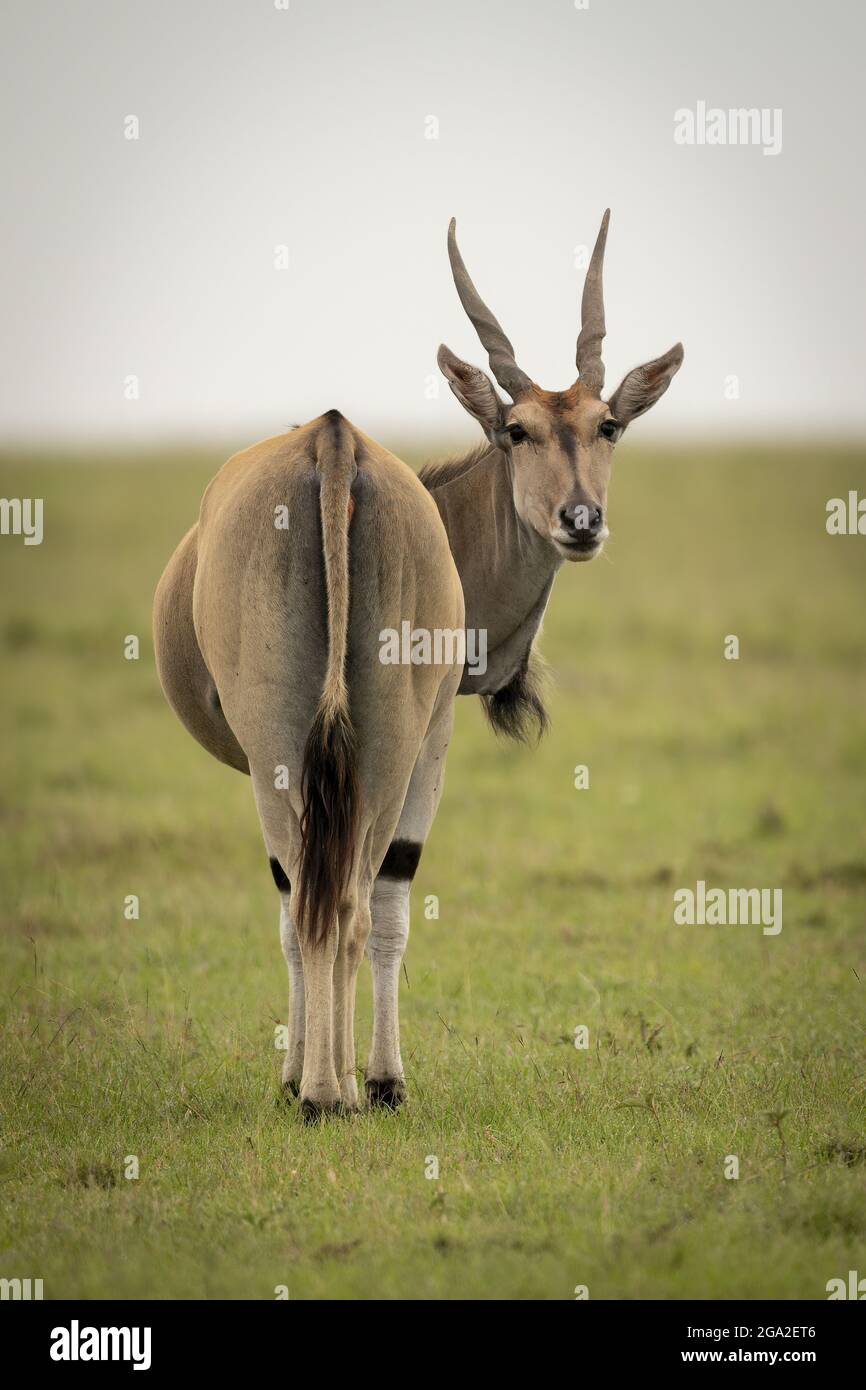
xmin=438 ymin=211 xmax=683 ymax=560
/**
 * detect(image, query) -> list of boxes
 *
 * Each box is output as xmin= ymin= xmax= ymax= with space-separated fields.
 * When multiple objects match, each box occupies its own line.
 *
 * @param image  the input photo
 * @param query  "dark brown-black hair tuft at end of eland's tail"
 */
xmin=295 ymin=709 xmax=357 ymax=945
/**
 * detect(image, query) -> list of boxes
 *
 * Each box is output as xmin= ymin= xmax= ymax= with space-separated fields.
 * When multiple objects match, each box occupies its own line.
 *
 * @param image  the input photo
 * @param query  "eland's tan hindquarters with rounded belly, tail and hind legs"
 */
xmin=154 ymin=410 xmax=464 ymax=1109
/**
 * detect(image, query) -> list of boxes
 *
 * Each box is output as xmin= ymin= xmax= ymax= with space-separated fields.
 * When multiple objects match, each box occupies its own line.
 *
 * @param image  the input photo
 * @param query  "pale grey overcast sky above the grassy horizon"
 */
xmin=0 ymin=0 xmax=866 ymax=442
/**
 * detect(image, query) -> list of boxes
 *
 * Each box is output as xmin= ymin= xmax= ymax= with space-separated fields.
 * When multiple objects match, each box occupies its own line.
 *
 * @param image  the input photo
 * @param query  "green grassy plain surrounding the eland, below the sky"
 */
xmin=0 ymin=441 xmax=866 ymax=1298
